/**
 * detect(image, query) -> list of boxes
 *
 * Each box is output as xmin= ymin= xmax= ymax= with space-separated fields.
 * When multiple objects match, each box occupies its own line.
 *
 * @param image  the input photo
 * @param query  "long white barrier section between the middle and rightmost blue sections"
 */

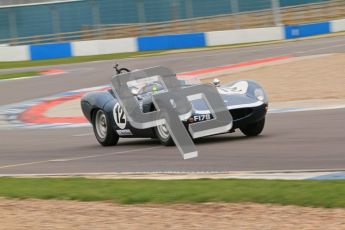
xmin=205 ymin=27 xmax=285 ymax=46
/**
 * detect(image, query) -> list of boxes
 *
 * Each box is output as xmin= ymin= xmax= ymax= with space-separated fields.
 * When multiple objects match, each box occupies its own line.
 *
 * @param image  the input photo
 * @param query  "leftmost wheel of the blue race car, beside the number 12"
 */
xmin=92 ymin=109 xmax=119 ymax=146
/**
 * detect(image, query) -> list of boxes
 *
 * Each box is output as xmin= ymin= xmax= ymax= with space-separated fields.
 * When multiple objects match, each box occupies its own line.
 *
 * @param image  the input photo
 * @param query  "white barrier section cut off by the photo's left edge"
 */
xmin=0 ymin=46 xmax=30 ymax=61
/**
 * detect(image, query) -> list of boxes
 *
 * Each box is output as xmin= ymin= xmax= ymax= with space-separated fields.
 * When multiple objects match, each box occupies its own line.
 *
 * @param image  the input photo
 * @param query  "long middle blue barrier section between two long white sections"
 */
xmin=137 ymin=33 xmax=206 ymax=51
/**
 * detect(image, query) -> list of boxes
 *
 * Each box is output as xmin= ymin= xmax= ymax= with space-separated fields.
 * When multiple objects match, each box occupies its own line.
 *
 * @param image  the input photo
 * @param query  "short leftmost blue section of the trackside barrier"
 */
xmin=30 ymin=42 xmax=72 ymax=60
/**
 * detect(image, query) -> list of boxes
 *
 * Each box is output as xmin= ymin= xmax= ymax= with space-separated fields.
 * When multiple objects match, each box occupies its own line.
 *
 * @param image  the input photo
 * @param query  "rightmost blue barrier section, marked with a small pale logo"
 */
xmin=285 ymin=22 xmax=330 ymax=39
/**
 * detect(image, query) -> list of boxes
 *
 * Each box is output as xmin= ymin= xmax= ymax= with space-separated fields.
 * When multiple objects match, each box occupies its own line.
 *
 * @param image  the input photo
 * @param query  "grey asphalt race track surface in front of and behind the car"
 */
xmin=0 ymin=36 xmax=345 ymax=174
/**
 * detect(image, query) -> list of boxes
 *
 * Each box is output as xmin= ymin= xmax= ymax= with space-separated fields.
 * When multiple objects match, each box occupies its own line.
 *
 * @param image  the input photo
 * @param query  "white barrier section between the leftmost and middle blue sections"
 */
xmin=71 ymin=38 xmax=138 ymax=56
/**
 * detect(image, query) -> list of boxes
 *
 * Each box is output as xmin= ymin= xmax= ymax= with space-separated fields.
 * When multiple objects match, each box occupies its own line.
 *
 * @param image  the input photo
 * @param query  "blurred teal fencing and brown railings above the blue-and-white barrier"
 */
xmin=0 ymin=0 xmax=345 ymax=45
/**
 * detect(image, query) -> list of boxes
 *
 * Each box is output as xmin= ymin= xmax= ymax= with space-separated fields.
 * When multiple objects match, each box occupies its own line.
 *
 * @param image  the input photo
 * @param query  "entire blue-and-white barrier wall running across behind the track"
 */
xmin=0 ymin=19 xmax=345 ymax=61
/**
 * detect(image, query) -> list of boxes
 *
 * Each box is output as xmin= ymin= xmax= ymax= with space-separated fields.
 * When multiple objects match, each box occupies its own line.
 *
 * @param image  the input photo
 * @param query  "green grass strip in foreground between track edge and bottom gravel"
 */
xmin=0 ymin=178 xmax=345 ymax=208
